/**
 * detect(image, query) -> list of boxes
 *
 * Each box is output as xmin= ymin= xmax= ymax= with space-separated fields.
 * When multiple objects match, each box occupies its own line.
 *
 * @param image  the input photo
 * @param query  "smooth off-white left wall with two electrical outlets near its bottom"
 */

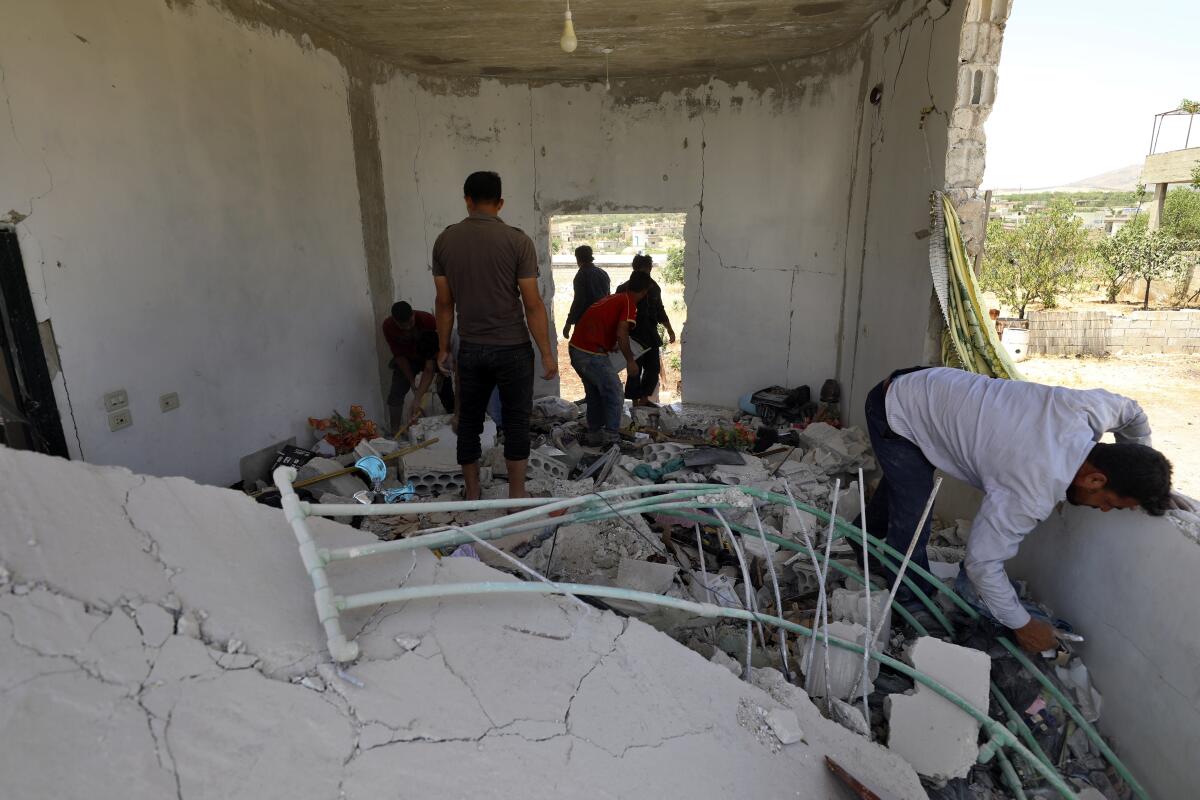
xmin=0 ymin=0 xmax=382 ymax=483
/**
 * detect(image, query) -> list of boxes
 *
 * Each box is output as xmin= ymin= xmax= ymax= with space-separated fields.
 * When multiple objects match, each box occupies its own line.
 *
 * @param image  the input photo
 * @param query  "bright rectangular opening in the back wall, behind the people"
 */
xmin=550 ymin=211 xmax=688 ymax=403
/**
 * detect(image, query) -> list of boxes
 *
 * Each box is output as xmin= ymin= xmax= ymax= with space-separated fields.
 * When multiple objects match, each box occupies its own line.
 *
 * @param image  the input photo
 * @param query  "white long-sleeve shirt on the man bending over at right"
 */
xmin=886 ymin=367 xmax=1150 ymax=628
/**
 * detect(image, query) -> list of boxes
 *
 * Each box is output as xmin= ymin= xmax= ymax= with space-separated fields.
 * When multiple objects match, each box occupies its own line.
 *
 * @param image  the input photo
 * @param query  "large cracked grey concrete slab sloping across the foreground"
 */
xmin=0 ymin=449 xmax=925 ymax=799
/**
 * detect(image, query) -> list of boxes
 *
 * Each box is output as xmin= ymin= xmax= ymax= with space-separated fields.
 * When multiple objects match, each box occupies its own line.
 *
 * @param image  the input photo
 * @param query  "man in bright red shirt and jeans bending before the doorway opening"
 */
xmin=570 ymin=272 xmax=650 ymax=445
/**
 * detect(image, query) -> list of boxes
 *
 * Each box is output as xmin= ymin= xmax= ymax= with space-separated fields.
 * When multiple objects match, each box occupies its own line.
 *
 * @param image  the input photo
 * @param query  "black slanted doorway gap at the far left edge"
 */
xmin=0 ymin=227 xmax=68 ymax=458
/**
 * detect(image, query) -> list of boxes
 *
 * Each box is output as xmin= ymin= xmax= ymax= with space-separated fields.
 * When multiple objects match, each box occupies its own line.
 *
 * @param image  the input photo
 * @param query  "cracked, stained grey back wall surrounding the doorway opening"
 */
xmin=376 ymin=1 xmax=962 ymax=417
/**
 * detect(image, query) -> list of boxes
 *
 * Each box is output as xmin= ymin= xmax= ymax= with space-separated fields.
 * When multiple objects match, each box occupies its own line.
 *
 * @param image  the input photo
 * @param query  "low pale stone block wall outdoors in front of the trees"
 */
xmin=1030 ymin=311 xmax=1200 ymax=355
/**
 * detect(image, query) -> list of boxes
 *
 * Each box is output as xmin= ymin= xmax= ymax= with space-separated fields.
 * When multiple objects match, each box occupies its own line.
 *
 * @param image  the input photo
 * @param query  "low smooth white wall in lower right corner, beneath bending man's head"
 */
xmin=1008 ymin=506 xmax=1200 ymax=798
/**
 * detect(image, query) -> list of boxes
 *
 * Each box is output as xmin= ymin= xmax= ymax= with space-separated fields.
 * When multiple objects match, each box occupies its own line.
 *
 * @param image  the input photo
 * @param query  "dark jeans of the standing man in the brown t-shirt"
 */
xmin=458 ymin=342 xmax=533 ymax=464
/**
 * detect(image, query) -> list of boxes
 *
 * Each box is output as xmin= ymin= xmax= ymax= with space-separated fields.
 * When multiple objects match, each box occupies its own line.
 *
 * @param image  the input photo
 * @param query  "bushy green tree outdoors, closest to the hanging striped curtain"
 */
xmin=980 ymin=198 xmax=1090 ymax=319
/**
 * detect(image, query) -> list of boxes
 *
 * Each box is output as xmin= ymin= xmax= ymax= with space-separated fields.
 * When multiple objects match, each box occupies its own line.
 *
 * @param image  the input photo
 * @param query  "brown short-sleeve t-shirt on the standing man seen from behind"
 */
xmin=433 ymin=213 xmax=538 ymax=344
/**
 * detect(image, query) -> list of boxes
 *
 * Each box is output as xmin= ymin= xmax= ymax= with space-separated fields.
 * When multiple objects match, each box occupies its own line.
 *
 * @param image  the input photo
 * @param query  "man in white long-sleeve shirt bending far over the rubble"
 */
xmin=866 ymin=367 xmax=1171 ymax=652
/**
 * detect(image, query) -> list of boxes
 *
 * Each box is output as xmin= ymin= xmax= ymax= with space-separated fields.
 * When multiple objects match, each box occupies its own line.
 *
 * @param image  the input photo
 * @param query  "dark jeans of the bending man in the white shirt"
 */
xmin=865 ymin=369 xmax=934 ymax=607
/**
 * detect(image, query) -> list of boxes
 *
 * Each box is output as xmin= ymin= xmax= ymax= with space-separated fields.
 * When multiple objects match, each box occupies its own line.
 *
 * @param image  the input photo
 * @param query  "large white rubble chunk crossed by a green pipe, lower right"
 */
xmin=884 ymin=636 xmax=991 ymax=780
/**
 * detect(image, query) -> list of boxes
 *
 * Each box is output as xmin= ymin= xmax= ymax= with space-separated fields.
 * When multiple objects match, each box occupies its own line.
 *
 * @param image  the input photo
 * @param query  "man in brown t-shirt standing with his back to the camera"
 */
xmin=433 ymin=173 xmax=558 ymax=500
